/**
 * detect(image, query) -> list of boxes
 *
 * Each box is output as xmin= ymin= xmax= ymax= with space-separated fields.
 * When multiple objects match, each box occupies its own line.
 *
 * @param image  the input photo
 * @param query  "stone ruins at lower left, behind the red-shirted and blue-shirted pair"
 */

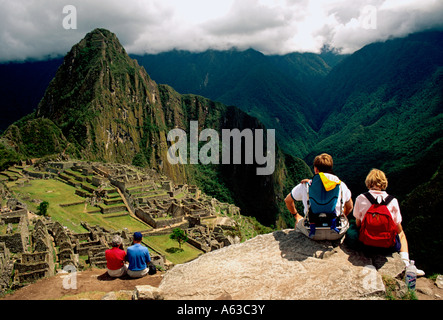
xmin=0 ymin=210 xmax=165 ymax=294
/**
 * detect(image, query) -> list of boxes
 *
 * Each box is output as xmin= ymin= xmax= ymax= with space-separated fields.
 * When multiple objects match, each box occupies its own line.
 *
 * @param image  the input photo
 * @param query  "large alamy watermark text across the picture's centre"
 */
xmin=167 ymin=121 xmax=275 ymax=175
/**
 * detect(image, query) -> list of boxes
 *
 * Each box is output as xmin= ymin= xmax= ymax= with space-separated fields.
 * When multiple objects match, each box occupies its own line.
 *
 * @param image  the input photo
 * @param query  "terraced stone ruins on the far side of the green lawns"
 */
xmin=50 ymin=162 xmax=240 ymax=252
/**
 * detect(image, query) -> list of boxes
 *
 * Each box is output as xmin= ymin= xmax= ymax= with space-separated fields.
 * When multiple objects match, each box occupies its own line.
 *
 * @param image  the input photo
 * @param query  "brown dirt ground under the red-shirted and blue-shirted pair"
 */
xmin=0 ymin=269 xmax=163 ymax=300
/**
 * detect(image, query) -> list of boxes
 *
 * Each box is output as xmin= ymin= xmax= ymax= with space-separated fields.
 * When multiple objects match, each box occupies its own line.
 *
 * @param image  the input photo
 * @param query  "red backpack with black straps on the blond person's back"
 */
xmin=358 ymin=192 xmax=397 ymax=248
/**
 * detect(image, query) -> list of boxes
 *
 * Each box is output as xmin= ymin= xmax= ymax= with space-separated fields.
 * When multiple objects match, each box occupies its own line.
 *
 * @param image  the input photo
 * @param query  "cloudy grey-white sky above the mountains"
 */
xmin=0 ymin=0 xmax=443 ymax=62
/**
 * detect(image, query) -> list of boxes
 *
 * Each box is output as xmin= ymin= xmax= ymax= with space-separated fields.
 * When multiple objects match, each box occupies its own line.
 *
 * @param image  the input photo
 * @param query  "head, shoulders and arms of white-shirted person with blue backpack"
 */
xmin=285 ymin=153 xmax=353 ymax=232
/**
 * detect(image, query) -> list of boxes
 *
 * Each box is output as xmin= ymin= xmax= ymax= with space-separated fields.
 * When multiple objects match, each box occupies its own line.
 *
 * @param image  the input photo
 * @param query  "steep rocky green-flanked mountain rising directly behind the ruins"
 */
xmin=2 ymin=29 xmax=311 ymax=227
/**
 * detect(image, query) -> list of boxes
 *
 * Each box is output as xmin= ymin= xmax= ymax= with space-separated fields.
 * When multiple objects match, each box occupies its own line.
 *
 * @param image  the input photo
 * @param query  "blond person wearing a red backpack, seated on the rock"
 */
xmin=353 ymin=169 xmax=424 ymax=276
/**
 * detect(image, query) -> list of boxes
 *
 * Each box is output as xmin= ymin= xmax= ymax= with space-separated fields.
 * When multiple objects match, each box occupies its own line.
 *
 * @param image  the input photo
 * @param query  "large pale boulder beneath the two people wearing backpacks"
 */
xmin=159 ymin=230 xmax=404 ymax=300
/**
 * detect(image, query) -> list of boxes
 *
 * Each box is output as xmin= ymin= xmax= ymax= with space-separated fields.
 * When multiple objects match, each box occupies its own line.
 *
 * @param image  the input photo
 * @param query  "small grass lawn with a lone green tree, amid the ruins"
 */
xmin=143 ymin=235 xmax=203 ymax=264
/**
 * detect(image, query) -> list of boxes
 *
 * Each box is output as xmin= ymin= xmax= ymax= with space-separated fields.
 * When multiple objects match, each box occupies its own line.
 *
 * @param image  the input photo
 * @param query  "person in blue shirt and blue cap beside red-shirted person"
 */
xmin=126 ymin=232 xmax=151 ymax=278
